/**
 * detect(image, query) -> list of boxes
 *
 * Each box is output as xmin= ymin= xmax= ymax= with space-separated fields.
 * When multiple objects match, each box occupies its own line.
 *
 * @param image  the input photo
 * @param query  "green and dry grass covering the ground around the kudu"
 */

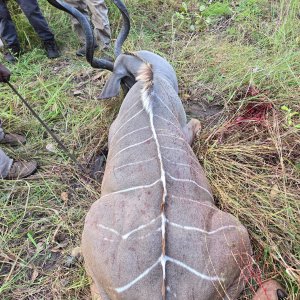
xmin=0 ymin=0 xmax=300 ymax=300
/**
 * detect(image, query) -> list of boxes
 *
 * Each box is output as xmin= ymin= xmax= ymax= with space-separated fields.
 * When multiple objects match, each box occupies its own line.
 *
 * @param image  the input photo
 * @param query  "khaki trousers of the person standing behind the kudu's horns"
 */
xmin=65 ymin=0 xmax=111 ymax=49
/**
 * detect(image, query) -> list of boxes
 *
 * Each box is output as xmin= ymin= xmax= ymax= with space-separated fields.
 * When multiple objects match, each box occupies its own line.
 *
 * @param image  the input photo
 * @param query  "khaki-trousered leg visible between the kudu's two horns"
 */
xmin=86 ymin=0 xmax=111 ymax=49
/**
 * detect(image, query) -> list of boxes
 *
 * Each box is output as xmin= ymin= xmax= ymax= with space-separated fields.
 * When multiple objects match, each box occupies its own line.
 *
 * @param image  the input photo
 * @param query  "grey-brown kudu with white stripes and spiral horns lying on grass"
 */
xmin=49 ymin=0 xmax=288 ymax=300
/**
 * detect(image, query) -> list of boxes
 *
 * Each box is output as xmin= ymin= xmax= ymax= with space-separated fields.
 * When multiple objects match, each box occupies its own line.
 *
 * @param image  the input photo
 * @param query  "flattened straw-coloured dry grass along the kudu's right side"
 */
xmin=195 ymin=110 xmax=300 ymax=299
